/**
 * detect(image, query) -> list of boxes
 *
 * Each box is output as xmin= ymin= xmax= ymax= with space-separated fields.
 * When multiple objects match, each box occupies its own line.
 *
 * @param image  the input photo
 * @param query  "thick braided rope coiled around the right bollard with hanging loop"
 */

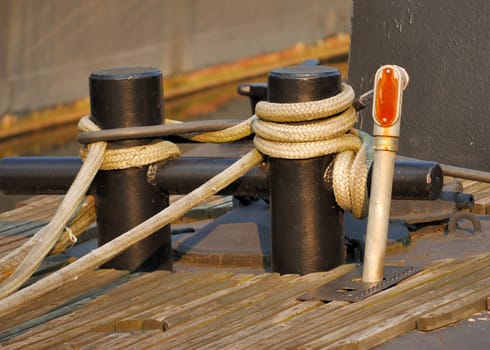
xmin=252 ymin=84 xmax=371 ymax=218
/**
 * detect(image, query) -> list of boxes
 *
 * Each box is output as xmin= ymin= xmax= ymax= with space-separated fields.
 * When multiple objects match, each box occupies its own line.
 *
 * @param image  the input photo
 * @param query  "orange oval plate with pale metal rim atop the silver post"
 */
xmin=374 ymin=66 xmax=402 ymax=127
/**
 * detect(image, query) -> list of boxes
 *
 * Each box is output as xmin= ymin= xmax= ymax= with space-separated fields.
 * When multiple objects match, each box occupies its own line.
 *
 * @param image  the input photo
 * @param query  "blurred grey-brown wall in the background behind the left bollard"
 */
xmin=0 ymin=0 xmax=352 ymax=115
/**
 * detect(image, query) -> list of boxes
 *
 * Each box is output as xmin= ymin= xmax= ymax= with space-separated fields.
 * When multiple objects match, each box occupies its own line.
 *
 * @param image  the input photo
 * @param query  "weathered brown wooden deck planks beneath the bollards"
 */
xmin=0 ymin=185 xmax=490 ymax=349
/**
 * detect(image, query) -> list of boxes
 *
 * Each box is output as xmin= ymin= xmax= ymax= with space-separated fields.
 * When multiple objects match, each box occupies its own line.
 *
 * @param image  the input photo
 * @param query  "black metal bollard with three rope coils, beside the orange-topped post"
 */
xmin=268 ymin=66 xmax=345 ymax=274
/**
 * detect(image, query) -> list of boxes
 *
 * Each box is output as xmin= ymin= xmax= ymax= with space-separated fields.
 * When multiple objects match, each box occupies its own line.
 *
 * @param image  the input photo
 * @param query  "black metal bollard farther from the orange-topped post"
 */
xmin=89 ymin=67 xmax=172 ymax=271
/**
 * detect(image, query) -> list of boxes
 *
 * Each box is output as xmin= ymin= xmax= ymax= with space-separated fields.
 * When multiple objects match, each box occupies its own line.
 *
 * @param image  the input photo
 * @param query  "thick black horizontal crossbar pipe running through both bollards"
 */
xmin=0 ymin=157 xmax=444 ymax=202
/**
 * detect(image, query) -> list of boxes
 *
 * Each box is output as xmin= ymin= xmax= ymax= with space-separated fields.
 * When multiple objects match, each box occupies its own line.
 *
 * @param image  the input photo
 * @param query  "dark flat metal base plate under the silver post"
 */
xmin=298 ymin=266 xmax=422 ymax=302
